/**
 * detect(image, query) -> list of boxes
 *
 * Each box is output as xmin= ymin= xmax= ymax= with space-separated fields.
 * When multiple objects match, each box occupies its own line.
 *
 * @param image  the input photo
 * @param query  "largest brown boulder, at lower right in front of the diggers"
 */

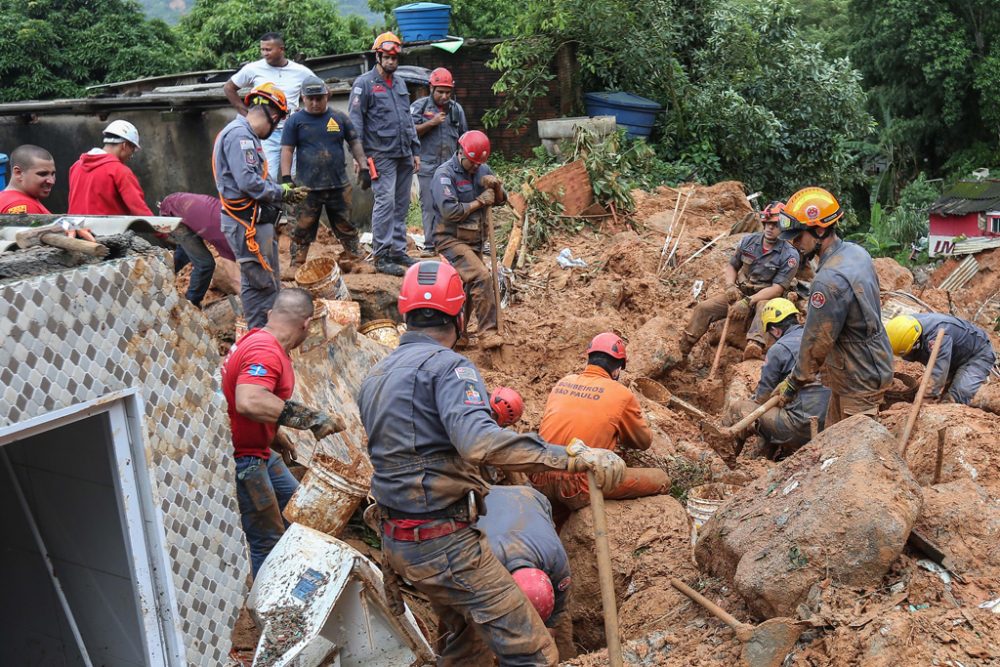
xmin=695 ymin=415 xmax=921 ymax=618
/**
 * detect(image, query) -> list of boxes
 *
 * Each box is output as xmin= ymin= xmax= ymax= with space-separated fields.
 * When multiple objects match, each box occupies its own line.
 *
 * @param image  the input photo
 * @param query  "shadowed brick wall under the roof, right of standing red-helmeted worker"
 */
xmin=402 ymin=40 xmax=559 ymax=155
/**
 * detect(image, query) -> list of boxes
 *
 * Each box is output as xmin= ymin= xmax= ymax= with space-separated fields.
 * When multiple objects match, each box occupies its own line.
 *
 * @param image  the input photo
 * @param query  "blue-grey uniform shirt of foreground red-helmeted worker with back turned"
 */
xmin=358 ymin=331 xmax=567 ymax=515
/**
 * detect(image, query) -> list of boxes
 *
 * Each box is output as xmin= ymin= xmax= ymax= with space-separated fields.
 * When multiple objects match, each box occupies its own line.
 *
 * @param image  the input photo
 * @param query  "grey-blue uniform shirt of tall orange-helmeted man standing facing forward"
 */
xmin=347 ymin=69 xmax=420 ymax=158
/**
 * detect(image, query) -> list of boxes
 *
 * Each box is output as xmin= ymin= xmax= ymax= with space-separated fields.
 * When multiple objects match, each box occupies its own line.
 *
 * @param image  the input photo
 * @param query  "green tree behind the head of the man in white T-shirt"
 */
xmin=175 ymin=0 xmax=371 ymax=68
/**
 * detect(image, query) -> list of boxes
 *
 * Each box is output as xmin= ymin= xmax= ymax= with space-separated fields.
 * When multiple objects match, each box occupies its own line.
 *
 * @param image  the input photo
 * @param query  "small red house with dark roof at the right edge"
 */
xmin=928 ymin=178 xmax=1000 ymax=257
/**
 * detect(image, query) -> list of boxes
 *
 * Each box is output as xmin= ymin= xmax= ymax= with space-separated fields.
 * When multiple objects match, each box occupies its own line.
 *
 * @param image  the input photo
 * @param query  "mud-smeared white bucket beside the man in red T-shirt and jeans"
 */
xmin=283 ymin=452 xmax=371 ymax=537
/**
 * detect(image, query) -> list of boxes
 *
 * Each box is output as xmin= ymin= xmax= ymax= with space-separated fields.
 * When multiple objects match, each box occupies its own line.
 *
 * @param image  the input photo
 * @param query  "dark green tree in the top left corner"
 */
xmin=0 ymin=0 xmax=179 ymax=102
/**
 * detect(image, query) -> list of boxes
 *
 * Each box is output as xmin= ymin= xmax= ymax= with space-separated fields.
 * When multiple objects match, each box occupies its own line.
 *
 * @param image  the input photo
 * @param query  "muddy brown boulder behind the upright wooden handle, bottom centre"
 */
xmin=560 ymin=496 xmax=697 ymax=650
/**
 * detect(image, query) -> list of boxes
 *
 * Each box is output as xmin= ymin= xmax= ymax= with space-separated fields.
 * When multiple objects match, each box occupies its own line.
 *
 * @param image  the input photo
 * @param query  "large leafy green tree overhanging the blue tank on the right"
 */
xmin=488 ymin=0 xmax=872 ymax=197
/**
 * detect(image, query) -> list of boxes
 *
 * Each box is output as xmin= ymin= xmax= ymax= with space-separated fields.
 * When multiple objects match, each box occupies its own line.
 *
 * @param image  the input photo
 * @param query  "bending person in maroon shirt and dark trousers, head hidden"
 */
xmin=160 ymin=192 xmax=236 ymax=308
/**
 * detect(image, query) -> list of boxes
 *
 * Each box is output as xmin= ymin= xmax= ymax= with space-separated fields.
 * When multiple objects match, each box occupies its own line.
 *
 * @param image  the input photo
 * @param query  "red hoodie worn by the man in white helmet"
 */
xmin=67 ymin=148 xmax=153 ymax=215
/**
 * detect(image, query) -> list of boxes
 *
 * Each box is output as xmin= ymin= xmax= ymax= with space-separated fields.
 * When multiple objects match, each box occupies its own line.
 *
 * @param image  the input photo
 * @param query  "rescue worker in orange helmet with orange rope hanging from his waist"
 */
xmin=212 ymin=83 xmax=306 ymax=329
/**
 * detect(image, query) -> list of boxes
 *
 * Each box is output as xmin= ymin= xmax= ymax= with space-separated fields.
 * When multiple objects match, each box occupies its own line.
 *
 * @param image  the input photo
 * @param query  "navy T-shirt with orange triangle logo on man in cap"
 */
xmin=281 ymin=109 xmax=358 ymax=190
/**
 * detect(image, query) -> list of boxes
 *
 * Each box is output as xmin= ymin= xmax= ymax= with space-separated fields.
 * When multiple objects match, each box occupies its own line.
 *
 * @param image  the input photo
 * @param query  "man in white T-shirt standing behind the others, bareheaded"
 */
xmin=222 ymin=32 xmax=315 ymax=181
